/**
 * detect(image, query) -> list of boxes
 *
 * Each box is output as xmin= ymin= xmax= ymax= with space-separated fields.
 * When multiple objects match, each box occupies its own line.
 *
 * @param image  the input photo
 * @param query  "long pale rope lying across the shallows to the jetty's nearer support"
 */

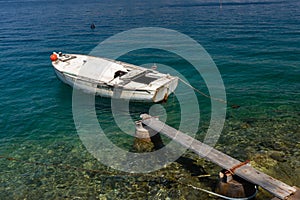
xmin=0 ymin=155 xmax=258 ymax=200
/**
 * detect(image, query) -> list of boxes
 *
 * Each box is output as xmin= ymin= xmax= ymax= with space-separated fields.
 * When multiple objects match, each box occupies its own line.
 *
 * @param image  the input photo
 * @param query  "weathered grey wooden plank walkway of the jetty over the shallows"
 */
xmin=141 ymin=114 xmax=300 ymax=200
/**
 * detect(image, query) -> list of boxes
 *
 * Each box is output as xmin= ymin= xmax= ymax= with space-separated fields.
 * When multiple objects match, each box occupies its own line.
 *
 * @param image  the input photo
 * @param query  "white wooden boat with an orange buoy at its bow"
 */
xmin=50 ymin=52 xmax=178 ymax=102
